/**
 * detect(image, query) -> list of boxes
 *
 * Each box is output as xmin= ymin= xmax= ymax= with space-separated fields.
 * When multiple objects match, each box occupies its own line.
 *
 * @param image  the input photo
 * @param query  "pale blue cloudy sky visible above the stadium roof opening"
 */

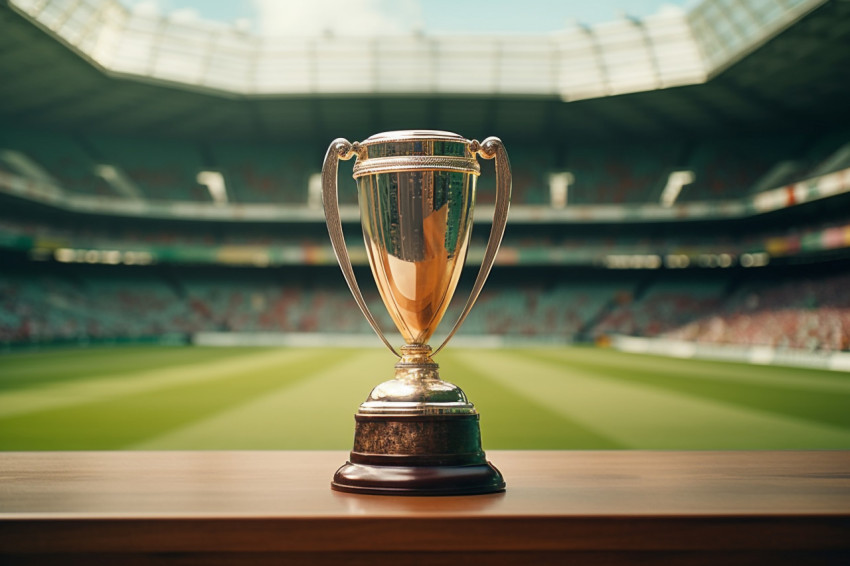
xmin=122 ymin=0 xmax=697 ymax=36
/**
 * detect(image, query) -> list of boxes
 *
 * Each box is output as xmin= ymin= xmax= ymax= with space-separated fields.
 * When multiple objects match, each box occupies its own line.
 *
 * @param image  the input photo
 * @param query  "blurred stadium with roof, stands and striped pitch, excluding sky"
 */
xmin=0 ymin=0 xmax=850 ymax=450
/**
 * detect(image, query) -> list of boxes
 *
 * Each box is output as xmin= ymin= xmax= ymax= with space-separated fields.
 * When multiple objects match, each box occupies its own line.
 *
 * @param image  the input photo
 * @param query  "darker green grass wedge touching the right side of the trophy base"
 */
xmin=440 ymin=349 xmax=624 ymax=450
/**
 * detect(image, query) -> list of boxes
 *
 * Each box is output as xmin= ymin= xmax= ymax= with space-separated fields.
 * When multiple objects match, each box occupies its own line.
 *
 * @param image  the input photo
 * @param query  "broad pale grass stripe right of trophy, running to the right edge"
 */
xmin=454 ymin=351 xmax=850 ymax=450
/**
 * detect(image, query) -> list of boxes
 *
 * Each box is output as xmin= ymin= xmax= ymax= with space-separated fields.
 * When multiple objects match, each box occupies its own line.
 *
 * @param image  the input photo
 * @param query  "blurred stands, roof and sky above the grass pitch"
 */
xmin=0 ymin=0 xmax=850 ymax=364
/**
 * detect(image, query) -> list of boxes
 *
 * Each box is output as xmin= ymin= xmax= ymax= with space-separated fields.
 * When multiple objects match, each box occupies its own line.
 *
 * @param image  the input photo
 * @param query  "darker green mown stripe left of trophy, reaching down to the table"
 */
xmin=0 ymin=350 xmax=352 ymax=450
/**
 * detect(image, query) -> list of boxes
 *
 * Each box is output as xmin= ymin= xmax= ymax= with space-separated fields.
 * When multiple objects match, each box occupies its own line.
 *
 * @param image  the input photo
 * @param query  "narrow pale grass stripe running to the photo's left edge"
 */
xmin=0 ymin=349 xmax=314 ymax=418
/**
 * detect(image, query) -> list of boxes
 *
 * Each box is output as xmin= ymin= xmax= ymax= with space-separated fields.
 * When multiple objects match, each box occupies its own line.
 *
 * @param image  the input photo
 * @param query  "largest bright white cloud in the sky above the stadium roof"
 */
xmin=253 ymin=0 xmax=422 ymax=37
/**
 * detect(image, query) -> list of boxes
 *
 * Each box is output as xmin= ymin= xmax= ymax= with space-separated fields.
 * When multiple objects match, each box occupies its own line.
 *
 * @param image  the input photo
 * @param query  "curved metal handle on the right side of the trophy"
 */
xmin=431 ymin=137 xmax=513 ymax=356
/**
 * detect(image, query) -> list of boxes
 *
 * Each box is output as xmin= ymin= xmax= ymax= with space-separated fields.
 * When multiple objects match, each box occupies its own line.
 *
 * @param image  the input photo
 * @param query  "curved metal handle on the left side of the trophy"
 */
xmin=322 ymin=138 xmax=401 ymax=358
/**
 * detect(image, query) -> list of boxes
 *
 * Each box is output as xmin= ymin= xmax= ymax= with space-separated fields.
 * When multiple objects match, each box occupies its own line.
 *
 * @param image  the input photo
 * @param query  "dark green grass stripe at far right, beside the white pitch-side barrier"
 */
xmin=523 ymin=350 xmax=850 ymax=429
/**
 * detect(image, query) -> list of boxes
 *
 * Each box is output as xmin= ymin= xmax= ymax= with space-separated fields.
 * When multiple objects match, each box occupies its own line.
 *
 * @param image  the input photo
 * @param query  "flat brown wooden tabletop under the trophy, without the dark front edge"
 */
xmin=0 ymin=451 xmax=850 ymax=518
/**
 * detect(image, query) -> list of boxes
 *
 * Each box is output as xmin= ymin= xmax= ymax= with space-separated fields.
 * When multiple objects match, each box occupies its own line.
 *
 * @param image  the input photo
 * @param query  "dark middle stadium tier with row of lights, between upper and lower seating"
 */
xmin=9 ymin=203 xmax=850 ymax=269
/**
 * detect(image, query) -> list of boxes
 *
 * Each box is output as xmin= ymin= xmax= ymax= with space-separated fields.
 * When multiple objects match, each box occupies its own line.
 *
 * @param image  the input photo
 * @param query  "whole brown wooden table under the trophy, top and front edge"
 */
xmin=0 ymin=451 xmax=850 ymax=566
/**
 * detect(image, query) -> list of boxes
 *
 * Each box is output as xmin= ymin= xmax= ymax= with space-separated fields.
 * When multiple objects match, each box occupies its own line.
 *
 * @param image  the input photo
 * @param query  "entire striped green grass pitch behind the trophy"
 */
xmin=0 ymin=346 xmax=850 ymax=450
